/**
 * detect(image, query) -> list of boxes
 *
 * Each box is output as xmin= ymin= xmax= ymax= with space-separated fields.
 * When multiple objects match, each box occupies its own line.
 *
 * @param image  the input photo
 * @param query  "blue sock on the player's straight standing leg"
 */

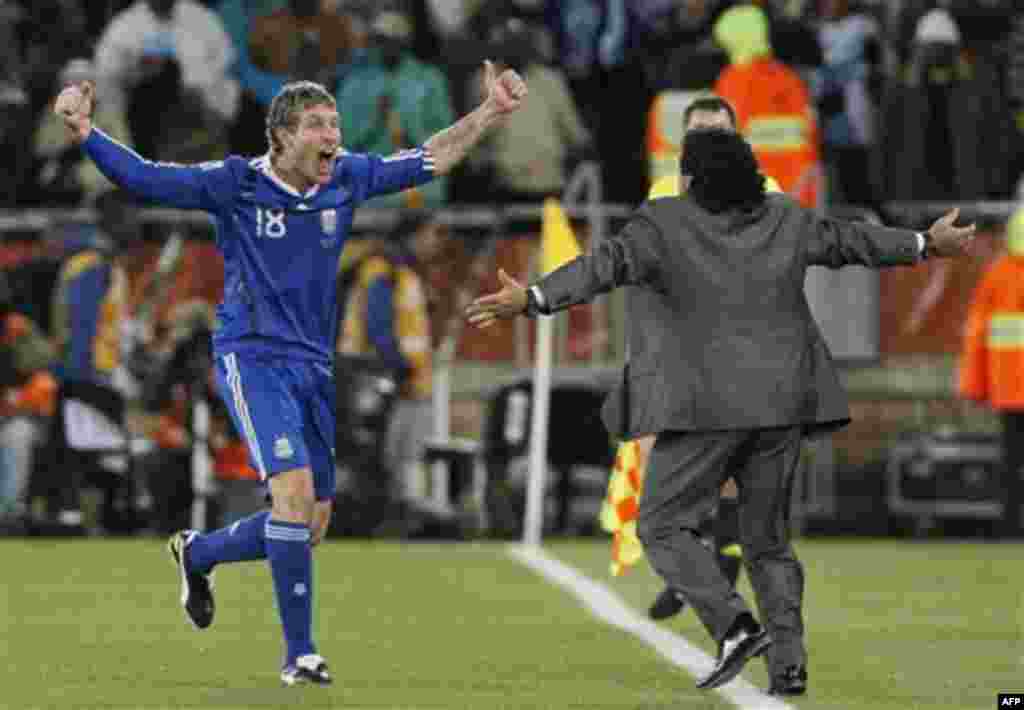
xmin=266 ymin=518 xmax=316 ymax=665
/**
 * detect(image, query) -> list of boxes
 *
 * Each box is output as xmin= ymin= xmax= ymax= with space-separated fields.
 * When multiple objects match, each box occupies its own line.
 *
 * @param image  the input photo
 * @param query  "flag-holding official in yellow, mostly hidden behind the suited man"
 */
xmin=603 ymin=96 xmax=781 ymax=620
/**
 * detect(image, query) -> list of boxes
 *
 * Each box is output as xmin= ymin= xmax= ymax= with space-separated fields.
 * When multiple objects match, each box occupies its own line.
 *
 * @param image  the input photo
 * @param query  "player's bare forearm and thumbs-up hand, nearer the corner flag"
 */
xmin=423 ymin=60 xmax=526 ymax=175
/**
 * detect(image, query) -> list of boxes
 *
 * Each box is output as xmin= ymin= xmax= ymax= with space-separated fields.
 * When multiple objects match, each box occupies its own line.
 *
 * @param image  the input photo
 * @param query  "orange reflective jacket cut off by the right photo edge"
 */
xmin=958 ymin=254 xmax=1024 ymax=410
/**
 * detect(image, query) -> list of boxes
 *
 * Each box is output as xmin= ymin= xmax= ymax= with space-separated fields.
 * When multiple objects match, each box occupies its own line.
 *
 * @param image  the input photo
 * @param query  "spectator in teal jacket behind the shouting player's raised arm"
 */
xmin=336 ymin=10 xmax=453 ymax=207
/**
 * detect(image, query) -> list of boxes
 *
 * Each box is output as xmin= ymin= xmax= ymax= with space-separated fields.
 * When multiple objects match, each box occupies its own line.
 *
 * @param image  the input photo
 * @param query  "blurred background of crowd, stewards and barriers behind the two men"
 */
xmin=0 ymin=0 xmax=1024 ymax=539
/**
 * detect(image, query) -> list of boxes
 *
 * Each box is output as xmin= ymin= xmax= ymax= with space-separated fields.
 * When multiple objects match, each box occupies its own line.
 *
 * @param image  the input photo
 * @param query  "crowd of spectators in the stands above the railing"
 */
xmin=0 ymin=0 xmax=1024 ymax=207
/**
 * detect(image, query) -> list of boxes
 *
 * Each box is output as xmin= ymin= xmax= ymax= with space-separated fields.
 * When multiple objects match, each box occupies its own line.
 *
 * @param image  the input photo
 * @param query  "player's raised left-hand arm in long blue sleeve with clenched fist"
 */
xmin=53 ymin=82 xmax=232 ymax=211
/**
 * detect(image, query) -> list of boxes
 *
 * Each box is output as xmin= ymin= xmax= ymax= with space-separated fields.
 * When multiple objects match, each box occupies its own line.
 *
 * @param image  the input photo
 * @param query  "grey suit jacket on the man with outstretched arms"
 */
xmin=535 ymin=195 xmax=921 ymax=440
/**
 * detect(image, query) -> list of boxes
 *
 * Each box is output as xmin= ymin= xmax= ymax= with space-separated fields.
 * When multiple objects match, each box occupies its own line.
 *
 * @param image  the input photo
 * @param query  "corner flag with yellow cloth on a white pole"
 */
xmin=522 ymin=198 xmax=580 ymax=546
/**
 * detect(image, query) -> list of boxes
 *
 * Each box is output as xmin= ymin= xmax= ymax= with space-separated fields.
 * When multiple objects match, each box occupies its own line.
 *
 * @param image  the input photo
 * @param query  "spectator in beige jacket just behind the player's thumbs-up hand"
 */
xmin=471 ymin=19 xmax=591 ymax=204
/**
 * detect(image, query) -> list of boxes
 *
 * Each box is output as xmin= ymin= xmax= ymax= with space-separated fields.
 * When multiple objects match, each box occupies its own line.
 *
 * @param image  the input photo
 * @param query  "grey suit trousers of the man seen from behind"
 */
xmin=637 ymin=427 xmax=807 ymax=673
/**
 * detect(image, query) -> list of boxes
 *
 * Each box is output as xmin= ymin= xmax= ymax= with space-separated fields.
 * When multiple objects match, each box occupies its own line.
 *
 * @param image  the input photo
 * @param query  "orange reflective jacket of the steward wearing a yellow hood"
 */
xmin=715 ymin=56 xmax=820 ymax=208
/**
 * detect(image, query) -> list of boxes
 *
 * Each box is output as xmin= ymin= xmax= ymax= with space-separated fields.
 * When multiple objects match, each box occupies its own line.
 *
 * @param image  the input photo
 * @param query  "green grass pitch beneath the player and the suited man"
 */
xmin=0 ymin=539 xmax=1024 ymax=710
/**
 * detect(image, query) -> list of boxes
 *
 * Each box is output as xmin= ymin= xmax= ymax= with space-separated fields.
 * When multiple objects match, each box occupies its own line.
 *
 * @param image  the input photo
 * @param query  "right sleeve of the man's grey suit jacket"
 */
xmin=805 ymin=212 xmax=921 ymax=268
